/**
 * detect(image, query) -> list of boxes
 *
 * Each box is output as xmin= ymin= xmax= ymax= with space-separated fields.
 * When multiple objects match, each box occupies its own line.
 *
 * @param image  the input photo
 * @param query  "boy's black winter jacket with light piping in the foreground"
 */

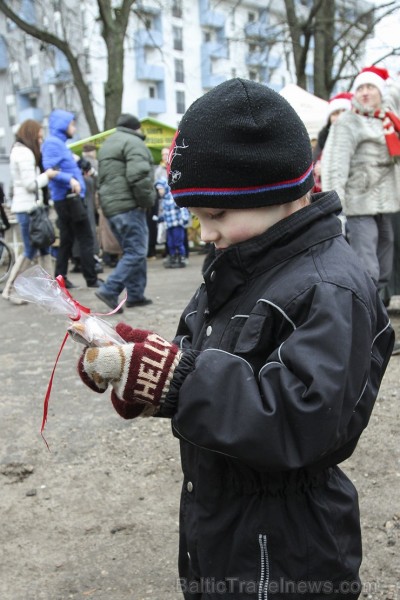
xmin=163 ymin=192 xmax=394 ymax=600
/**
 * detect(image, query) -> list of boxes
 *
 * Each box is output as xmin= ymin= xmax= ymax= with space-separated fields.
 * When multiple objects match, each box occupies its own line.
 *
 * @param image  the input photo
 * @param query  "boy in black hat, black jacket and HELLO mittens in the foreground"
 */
xmin=79 ymin=79 xmax=394 ymax=600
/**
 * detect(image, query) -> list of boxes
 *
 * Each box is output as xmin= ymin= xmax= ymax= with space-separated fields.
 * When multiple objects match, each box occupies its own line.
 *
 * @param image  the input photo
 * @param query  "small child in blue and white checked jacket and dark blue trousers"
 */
xmin=155 ymin=178 xmax=190 ymax=269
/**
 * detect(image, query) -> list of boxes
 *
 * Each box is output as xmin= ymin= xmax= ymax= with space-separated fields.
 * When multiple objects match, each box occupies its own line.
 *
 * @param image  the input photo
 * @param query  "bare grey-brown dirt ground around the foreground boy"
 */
xmin=0 ymin=255 xmax=400 ymax=600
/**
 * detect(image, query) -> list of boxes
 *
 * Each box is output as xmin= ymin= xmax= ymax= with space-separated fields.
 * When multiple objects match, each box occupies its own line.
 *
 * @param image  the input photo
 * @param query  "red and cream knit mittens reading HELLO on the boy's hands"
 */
xmin=78 ymin=324 xmax=181 ymax=419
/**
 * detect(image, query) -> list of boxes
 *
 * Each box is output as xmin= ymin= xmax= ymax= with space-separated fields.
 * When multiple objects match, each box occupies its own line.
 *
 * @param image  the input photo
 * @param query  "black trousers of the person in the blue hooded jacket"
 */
xmin=54 ymin=200 xmax=97 ymax=285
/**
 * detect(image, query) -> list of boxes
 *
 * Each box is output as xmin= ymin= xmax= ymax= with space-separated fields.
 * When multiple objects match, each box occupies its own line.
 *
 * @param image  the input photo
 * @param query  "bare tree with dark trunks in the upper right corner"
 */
xmin=285 ymin=0 xmax=400 ymax=99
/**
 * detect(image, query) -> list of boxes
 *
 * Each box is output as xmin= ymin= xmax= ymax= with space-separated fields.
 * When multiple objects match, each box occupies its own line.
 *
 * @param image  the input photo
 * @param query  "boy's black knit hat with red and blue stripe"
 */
xmin=168 ymin=79 xmax=314 ymax=208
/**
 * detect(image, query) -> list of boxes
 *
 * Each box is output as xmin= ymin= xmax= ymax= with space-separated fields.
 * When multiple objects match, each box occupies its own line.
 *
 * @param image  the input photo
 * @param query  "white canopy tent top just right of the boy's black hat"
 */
xmin=279 ymin=83 xmax=328 ymax=139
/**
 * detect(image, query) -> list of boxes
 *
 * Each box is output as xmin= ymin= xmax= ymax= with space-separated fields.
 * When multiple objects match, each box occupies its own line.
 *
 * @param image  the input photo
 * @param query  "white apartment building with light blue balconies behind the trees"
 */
xmin=0 ymin=0 xmax=374 ymax=188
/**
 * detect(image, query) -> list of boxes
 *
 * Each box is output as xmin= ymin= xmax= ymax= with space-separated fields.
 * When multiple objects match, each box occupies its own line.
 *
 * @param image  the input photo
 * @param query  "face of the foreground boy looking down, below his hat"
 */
xmin=189 ymin=202 xmax=301 ymax=250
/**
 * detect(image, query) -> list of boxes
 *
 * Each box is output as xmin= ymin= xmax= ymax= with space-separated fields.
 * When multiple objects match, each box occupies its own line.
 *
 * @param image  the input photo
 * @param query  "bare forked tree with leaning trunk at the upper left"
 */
xmin=0 ymin=0 xmax=135 ymax=134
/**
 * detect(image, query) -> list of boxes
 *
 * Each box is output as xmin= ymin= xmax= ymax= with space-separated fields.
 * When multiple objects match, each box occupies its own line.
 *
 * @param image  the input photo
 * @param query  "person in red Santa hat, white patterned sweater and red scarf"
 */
xmin=322 ymin=67 xmax=400 ymax=294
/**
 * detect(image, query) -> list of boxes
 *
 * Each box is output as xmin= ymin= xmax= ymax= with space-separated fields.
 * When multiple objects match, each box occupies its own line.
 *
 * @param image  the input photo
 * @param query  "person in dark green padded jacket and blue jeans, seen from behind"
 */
xmin=96 ymin=113 xmax=155 ymax=312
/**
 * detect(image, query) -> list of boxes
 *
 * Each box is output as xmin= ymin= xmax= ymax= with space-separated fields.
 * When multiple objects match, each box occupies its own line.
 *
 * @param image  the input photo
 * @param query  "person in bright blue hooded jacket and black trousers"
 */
xmin=42 ymin=109 xmax=101 ymax=287
